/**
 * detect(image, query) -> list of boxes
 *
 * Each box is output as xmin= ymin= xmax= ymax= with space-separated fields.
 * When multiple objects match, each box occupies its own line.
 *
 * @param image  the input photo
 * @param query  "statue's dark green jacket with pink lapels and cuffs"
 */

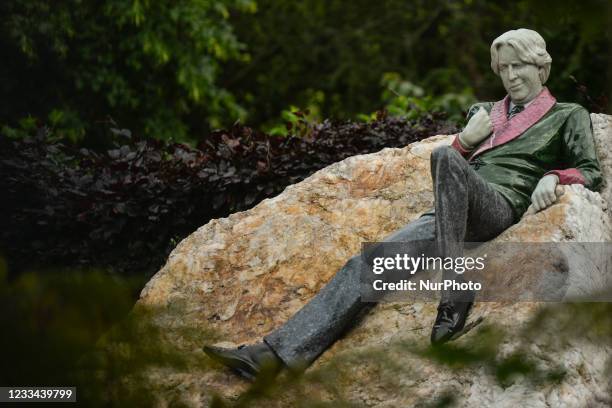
xmin=452 ymin=88 xmax=602 ymax=220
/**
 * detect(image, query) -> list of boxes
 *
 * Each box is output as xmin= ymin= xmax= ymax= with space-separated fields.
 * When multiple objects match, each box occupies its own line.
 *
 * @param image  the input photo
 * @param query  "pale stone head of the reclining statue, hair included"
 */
xmin=491 ymin=28 xmax=552 ymax=105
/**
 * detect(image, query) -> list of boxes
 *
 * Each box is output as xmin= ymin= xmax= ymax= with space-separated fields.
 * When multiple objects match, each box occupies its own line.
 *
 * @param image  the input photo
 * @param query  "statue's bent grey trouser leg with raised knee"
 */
xmin=431 ymin=146 xmax=514 ymax=286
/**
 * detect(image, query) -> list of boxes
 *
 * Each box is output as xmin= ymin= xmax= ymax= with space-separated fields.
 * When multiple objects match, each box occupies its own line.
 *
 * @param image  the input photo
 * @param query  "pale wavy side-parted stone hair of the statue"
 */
xmin=491 ymin=28 xmax=552 ymax=84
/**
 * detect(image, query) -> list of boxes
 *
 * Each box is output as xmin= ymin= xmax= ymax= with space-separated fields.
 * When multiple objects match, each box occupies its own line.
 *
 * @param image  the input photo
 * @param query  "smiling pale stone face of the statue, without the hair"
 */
xmin=498 ymin=45 xmax=542 ymax=105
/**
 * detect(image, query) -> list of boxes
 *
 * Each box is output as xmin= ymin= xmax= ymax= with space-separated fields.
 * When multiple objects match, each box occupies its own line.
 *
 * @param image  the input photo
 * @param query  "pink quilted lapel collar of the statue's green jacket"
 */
xmin=469 ymin=87 xmax=557 ymax=160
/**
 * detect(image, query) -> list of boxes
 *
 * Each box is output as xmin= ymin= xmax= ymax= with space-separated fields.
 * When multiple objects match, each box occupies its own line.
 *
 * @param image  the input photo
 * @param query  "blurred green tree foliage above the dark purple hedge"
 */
xmin=0 ymin=0 xmax=612 ymax=141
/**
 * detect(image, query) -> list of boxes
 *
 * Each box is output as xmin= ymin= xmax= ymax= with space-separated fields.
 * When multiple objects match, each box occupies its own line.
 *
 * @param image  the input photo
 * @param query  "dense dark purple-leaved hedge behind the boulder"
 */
xmin=0 ymin=116 xmax=455 ymax=274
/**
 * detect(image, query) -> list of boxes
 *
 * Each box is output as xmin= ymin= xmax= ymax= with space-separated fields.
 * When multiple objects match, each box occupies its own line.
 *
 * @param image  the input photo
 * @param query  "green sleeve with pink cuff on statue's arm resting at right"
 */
xmin=546 ymin=107 xmax=602 ymax=190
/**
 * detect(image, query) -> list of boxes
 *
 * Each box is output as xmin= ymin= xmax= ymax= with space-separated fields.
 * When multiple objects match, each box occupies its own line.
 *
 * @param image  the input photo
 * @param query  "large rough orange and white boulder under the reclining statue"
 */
xmin=138 ymin=115 xmax=612 ymax=407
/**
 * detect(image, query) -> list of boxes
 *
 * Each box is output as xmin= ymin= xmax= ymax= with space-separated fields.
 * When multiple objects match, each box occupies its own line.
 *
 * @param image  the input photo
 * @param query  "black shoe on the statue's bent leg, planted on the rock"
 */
xmin=431 ymin=292 xmax=474 ymax=345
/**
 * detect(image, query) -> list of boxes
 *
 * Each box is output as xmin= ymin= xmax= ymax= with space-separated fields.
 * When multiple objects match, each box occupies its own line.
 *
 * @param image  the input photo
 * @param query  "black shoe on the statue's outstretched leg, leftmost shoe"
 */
xmin=203 ymin=343 xmax=283 ymax=381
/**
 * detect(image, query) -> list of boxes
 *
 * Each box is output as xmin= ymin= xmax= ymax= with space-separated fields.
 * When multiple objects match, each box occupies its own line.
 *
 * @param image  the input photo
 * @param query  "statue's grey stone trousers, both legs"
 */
xmin=264 ymin=146 xmax=514 ymax=367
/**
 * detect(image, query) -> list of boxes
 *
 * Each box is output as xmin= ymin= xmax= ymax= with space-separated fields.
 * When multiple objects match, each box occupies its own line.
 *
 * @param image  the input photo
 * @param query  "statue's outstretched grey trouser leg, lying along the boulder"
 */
xmin=264 ymin=214 xmax=435 ymax=367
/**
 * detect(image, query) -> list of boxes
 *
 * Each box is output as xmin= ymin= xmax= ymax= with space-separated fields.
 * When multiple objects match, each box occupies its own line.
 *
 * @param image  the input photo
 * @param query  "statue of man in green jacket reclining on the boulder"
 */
xmin=204 ymin=29 xmax=601 ymax=379
